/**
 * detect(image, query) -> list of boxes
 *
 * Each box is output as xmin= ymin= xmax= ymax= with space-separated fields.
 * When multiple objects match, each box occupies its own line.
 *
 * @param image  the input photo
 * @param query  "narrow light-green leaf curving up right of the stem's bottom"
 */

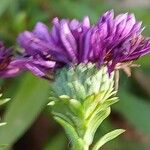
xmin=92 ymin=129 xmax=125 ymax=150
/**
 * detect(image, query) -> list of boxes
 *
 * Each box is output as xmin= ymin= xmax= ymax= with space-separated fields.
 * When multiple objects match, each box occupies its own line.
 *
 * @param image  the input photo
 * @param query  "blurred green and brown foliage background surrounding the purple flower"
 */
xmin=0 ymin=0 xmax=150 ymax=150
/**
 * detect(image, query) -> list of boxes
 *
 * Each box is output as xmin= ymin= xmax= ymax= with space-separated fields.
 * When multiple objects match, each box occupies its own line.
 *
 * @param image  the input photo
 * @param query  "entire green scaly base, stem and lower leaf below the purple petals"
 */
xmin=49 ymin=64 xmax=124 ymax=150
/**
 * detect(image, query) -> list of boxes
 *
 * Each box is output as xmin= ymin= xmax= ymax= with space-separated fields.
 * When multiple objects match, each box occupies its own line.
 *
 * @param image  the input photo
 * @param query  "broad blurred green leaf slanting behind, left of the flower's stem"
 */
xmin=0 ymin=74 xmax=50 ymax=147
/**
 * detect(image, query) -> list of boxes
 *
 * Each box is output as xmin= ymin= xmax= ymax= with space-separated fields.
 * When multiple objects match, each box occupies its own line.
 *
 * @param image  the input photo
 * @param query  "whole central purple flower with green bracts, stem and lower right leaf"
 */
xmin=15 ymin=11 xmax=150 ymax=150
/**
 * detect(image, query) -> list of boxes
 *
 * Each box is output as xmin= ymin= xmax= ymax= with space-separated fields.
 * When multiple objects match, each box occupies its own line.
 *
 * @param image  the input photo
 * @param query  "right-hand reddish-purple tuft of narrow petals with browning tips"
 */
xmin=91 ymin=11 xmax=150 ymax=71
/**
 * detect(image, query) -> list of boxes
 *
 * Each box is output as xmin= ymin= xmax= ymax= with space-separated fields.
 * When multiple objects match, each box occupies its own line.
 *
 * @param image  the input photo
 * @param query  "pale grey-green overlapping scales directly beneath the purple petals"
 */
xmin=52 ymin=63 xmax=114 ymax=101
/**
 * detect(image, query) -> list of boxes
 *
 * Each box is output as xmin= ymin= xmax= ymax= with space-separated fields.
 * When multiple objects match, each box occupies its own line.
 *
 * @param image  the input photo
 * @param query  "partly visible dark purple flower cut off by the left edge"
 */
xmin=0 ymin=42 xmax=20 ymax=77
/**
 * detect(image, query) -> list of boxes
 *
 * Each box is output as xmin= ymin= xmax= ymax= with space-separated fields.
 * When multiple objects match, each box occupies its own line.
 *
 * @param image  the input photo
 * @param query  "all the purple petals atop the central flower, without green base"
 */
xmin=2 ymin=11 xmax=150 ymax=78
